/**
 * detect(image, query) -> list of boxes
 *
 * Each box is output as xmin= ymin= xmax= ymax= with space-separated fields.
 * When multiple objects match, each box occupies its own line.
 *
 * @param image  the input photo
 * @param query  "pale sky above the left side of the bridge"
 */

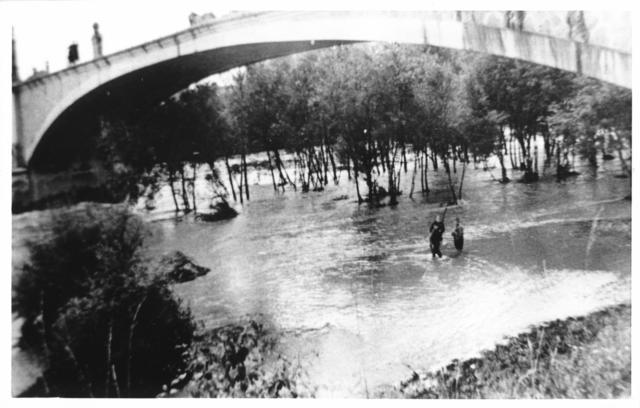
xmin=8 ymin=0 xmax=232 ymax=79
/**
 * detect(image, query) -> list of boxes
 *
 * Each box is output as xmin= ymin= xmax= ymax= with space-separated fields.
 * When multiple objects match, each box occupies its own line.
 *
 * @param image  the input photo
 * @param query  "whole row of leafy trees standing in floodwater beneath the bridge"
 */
xmin=102 ymin=44 xmax=631 ymax=211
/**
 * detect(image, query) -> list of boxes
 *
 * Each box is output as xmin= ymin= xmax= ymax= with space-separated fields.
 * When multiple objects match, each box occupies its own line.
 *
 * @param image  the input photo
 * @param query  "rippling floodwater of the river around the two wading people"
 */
xmin=14 ymin=155 xmax=631 ymax=397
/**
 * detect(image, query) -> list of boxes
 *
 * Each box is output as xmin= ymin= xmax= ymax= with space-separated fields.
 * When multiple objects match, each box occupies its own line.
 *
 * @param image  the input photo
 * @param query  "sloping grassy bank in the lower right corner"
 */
xmin=387 ymin=304 xmax=631 ymax=398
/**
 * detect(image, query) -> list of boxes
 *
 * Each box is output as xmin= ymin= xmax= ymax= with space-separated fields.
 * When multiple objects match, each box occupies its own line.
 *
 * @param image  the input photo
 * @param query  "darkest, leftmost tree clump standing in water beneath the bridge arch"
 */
xmin=99 ymin=85 xmax=236 ymax=213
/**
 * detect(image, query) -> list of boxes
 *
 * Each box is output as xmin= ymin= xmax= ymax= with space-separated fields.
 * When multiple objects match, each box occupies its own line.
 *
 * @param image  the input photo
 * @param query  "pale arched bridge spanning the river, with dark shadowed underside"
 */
xmin=13 ymin=11 xmax=632 ymax=171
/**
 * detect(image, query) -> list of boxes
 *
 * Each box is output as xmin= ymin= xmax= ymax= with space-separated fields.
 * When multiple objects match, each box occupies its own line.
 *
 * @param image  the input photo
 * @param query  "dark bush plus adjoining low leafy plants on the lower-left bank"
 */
xmin=13 ymin=207 xmax=314 ymax=397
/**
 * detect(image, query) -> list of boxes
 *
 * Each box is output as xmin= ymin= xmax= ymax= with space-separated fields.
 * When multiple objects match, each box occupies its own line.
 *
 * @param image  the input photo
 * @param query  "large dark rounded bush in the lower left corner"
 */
xmin=13 ymin=208 xmax=195 ymax=397
